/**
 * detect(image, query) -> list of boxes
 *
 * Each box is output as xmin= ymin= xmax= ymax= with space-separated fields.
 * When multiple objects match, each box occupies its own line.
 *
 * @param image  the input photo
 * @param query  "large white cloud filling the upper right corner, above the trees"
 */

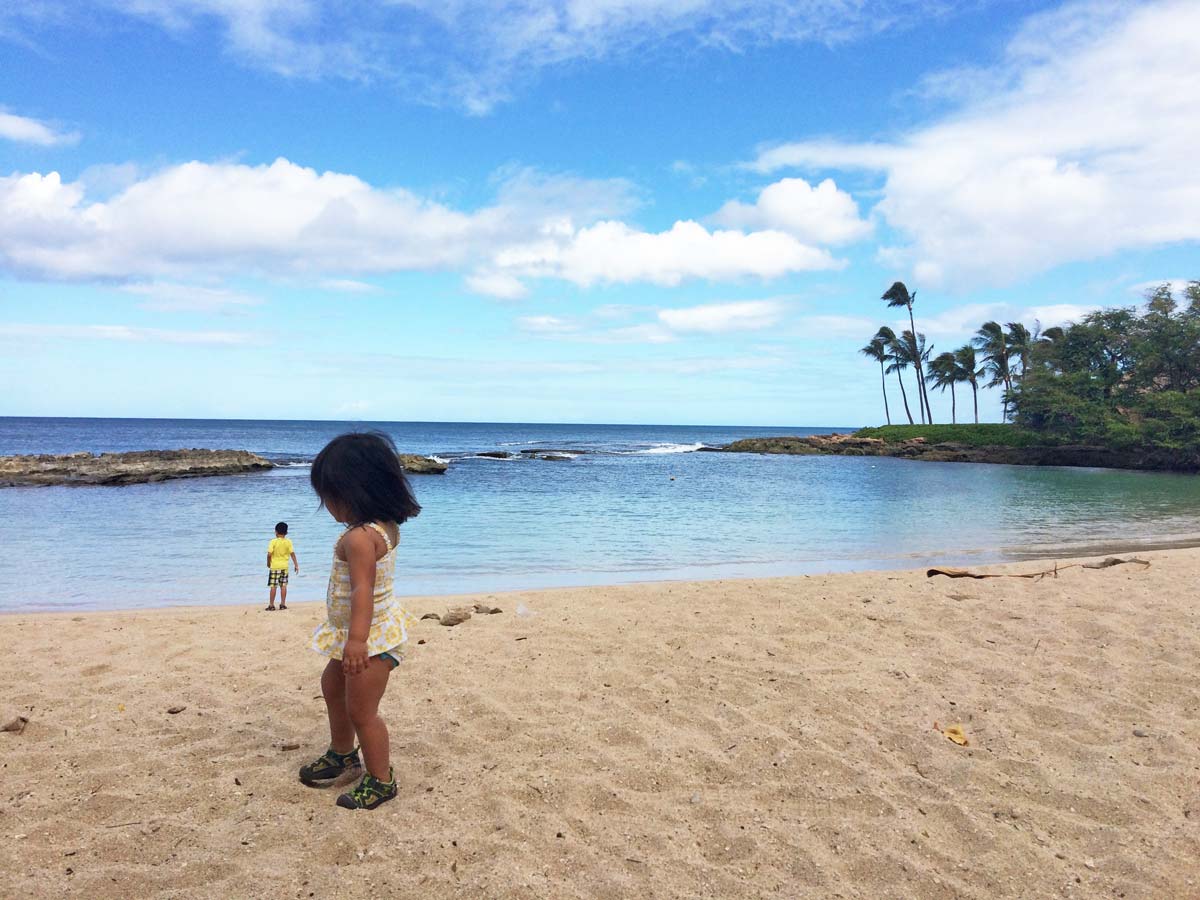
xmin=754 ymin=0 xmax=1200 ymax=288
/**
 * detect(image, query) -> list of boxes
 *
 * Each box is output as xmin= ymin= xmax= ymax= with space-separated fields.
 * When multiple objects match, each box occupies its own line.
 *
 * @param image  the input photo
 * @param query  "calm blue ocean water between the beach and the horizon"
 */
xmin=0 ymin=418 xmax=1200 ymax=611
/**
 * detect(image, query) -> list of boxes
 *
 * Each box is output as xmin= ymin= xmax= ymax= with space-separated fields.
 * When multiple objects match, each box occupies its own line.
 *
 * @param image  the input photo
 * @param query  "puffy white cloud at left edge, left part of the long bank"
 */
xmin=0 ymin=160 xmax=487 ymax=278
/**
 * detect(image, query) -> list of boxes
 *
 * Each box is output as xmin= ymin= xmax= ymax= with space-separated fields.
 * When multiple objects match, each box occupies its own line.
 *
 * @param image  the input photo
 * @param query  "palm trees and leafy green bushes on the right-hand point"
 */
xmin=856 ymin=281 xmax=1200 ymax=460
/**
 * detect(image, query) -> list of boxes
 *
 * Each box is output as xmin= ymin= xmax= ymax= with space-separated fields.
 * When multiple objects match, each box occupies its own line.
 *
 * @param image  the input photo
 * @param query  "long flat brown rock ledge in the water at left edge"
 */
xmin=0 ymin=450 xmax=275 ymax=486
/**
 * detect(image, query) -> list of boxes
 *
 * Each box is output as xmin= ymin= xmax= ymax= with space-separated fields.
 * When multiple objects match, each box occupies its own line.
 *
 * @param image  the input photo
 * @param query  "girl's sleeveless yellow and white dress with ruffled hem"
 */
xmin=310 ymin=522 xmax=416 ymax=662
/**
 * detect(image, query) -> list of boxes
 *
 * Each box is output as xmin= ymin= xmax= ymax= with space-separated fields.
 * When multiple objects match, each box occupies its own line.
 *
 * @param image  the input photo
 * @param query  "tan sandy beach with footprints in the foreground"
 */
xmin=0 ymin=550 xmax=1200 ymax=898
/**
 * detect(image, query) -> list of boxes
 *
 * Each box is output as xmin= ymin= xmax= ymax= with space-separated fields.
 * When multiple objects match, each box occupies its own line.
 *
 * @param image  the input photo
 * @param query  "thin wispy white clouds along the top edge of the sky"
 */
xmin=16 ymin=0 xmax=950 ymax=113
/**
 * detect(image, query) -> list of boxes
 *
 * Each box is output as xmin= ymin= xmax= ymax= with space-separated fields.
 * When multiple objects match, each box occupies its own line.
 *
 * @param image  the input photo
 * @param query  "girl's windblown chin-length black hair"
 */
xmin=310 ymin=431 xmax=421 ymax=526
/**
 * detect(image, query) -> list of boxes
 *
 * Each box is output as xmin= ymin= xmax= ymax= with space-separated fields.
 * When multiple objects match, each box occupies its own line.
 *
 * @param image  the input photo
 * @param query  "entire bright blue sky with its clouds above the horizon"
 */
xmin=0 ymin=0 xmax=1200 ymax=425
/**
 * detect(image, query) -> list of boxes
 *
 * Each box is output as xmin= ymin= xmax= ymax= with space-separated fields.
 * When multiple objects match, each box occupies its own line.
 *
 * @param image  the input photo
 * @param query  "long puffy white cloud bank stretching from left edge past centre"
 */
xmin=0 ymin=158 xmax=841 ymax=292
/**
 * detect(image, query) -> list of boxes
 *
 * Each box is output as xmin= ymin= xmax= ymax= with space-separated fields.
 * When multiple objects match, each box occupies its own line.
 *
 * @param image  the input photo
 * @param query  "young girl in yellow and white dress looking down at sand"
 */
xmin=300 ymin=433 xmax=421 ymax=809
